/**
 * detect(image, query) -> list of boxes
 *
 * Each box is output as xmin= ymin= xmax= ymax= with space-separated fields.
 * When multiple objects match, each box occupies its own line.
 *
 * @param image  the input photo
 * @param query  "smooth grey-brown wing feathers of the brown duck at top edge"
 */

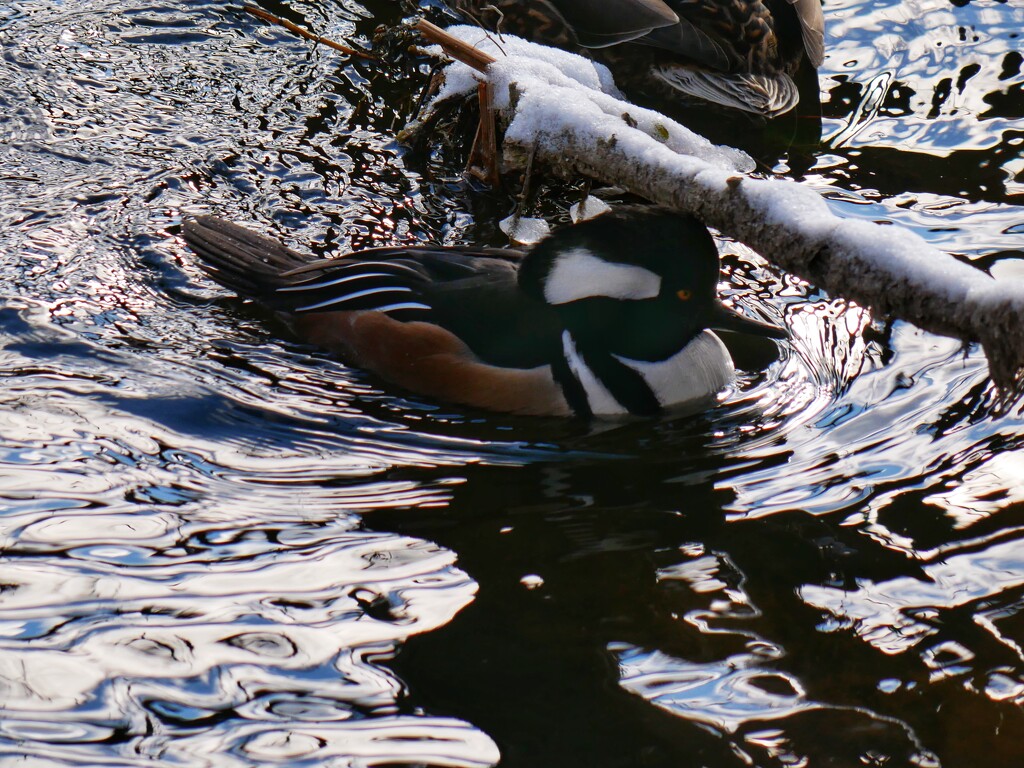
xmin=549 ymin=0 xmax=679 ymax=48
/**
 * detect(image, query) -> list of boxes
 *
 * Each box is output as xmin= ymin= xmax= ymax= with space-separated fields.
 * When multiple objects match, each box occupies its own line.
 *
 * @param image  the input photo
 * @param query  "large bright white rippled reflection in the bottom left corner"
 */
xmin=0 ymin=532 xmax=496 ymax=766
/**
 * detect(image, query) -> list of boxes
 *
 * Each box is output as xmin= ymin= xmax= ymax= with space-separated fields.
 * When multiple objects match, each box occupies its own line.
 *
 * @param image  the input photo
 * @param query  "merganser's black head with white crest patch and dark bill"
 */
xmin=519 ymin=208 xmax=786 ymax=360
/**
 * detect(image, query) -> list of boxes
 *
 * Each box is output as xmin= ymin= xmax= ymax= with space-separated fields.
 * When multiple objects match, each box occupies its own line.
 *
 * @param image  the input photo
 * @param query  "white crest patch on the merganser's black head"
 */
xmin=544 ymin=248 xmax=662 ymax=304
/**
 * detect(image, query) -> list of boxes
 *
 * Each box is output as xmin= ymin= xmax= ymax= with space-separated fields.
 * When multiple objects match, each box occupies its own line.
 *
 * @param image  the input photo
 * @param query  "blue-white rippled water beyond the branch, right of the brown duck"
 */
xmin=806 ymin=0 xmax=1024 ymax=258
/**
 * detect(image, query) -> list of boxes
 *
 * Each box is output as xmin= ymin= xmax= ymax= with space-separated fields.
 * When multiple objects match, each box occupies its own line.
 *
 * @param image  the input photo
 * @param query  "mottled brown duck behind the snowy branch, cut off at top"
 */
xmin=452 ymin=0 xmax=824 ymax=117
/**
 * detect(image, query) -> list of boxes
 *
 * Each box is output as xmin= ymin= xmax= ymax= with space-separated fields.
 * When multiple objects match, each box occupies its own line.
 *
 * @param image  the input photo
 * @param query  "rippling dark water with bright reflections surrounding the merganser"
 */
xmin=0 ymin=0 xmax=1024 ymax=768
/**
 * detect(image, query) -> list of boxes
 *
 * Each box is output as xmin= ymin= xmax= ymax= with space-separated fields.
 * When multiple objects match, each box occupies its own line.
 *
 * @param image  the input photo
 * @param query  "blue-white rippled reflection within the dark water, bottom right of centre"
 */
xmin=608 ymin=544 xmax=938 ymax=767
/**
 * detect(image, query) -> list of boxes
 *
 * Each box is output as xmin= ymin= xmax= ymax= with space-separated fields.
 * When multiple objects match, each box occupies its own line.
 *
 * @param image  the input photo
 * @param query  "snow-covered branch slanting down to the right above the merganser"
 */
xmin=419 ymin=23 xmax=1024 ymax=395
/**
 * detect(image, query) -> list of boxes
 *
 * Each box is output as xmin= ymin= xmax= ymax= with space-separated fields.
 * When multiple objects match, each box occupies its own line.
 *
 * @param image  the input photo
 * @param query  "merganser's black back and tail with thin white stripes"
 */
xmin=182 ymin=216 xmax=562 ymax=368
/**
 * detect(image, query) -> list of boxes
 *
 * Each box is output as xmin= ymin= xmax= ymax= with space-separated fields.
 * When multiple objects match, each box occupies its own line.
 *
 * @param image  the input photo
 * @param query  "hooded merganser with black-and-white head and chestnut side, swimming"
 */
xmin=183 ymin=209 xmax=786 ymax=416
